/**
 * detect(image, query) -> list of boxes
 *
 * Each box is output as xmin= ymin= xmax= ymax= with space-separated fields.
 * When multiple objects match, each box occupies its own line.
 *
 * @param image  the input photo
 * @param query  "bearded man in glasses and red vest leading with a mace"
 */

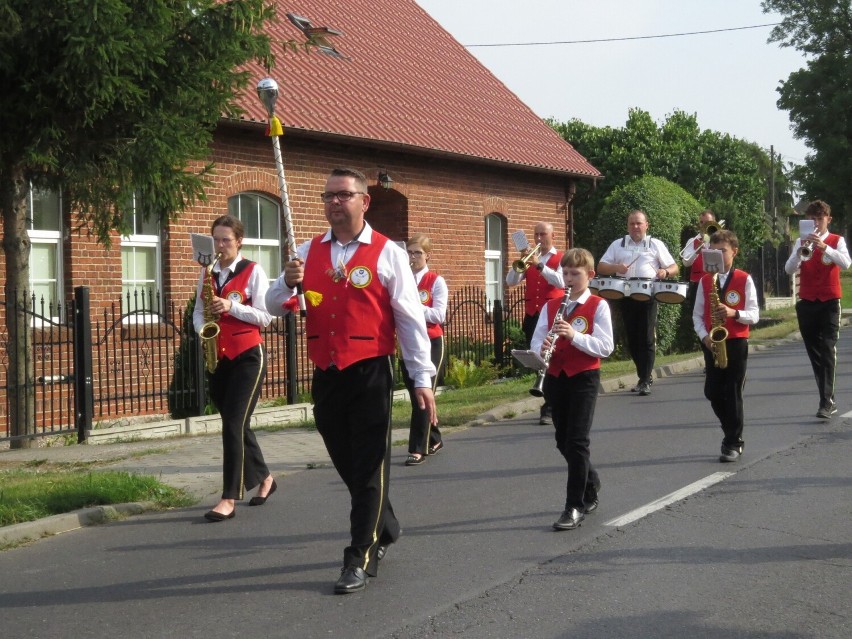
xmin=266 ymin=169 xmax=438 ymax=594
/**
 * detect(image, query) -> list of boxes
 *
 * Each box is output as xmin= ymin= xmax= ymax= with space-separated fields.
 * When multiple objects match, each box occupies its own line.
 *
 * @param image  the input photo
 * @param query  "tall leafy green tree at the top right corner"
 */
xmin=762 ymin=0 xmax=852 ymax=225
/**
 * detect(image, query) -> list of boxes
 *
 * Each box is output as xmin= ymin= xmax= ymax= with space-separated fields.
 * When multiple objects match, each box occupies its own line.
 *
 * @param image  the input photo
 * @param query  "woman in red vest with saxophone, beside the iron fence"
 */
xmin=192 ymin=215 xmax=277 ymax=522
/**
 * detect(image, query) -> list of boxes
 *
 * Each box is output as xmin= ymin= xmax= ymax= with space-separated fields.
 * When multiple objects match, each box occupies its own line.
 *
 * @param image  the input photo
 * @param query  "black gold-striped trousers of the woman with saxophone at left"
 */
xmin=210 ymin=345 xmax=269 ymax=499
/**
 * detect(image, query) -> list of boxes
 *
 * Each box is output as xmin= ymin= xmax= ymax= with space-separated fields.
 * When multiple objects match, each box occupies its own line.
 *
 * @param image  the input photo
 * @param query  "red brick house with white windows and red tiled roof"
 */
xmin=0 ymin=0 xmax=600 ymax=436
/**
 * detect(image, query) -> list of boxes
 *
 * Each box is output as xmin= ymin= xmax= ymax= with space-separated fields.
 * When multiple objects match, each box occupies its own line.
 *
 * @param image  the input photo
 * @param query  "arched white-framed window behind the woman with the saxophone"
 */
xmin=228 ymin=193 xmax=282 ymax=283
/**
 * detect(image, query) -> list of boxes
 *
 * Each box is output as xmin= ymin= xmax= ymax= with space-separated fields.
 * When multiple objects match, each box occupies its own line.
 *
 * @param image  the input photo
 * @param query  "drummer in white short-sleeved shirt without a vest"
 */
xmin=597 ymin=210 xmax=678 ymax=395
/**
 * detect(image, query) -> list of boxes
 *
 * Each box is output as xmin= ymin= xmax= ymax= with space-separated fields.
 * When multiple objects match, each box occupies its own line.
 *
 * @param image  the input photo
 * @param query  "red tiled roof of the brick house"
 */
xmin=233 ymin=0 xmax=600 ymax=177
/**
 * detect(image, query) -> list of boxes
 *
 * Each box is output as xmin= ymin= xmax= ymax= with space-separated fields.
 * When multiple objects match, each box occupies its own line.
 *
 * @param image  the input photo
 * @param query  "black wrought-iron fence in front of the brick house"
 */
xmin=0 ymin=286 xmax=523 ymax=440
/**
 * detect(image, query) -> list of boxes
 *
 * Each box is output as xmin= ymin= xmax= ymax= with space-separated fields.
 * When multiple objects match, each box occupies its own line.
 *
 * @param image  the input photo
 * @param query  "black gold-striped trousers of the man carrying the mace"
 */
xmin=311 ymin=356 xmax=400 ymax=577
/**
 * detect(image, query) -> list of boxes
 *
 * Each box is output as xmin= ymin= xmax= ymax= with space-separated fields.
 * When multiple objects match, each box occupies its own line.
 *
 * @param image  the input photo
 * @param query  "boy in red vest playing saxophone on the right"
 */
xmin=692 ymin=230 xmax=760 ymax=462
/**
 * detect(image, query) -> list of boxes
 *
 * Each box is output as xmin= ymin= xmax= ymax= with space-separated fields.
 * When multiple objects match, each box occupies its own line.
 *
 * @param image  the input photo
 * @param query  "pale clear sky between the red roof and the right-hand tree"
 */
xmin=416 ymin=0 xmax=807 ymax=168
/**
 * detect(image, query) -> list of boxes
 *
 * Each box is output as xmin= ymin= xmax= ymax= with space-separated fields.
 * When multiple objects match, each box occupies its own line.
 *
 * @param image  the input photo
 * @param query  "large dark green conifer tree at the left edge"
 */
xmin=0 ymin=0 xmax=273 ymax=446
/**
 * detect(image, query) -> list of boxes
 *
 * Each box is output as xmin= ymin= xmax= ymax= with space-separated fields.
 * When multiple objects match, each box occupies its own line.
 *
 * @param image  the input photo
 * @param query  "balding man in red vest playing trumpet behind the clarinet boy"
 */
xmin=506 ymin=222 xmax=563 ymax=424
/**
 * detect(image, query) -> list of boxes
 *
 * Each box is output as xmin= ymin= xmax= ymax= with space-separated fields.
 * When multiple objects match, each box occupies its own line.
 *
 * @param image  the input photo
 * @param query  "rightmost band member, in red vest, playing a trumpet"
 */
xmin=784 ymin=200 xmax=852 ymax=419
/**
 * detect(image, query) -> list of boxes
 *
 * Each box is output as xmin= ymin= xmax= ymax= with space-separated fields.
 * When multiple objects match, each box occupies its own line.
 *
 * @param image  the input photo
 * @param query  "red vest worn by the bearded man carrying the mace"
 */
xmin=302 ymin=231 xmax=396 ymax=370
